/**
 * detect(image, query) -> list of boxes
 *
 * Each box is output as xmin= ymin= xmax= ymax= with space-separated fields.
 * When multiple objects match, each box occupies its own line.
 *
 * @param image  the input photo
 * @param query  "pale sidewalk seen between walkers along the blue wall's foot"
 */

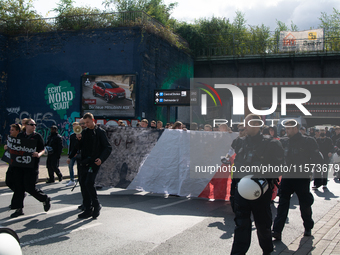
xmin=0 ymin=155 xmax=73 ymax=187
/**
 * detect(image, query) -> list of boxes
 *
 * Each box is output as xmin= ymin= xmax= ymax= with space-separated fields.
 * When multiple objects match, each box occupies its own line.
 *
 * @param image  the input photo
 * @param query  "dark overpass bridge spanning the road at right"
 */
xmin=194 ymin=51 xmax=340 ymax=127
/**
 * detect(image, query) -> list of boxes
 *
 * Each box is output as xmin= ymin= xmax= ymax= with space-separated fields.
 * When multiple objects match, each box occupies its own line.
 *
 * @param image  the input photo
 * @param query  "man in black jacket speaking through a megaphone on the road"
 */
xmin=67 ymin=113 xmax=112 ymax=219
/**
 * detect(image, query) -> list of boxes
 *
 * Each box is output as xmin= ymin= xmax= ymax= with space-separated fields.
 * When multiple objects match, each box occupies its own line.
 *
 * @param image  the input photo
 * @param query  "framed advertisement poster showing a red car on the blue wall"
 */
xmin=82 ymin=75 xmax=136 ymax=117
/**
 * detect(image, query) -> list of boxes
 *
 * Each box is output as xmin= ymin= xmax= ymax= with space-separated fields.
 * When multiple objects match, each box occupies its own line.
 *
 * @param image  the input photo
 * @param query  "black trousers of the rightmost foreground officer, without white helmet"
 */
xmin=273 ymin=178 xmax=314 ymax=233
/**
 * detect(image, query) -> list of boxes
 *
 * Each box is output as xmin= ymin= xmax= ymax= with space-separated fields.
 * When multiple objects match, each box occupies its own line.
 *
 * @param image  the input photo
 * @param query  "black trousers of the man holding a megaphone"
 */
xmin=78 ymin=165 xmax=99 ymax=210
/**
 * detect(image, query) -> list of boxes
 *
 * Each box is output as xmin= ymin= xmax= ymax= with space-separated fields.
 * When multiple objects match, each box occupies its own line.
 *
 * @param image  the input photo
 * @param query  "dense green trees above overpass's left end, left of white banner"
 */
xmin=176 ymin=12 xmax=270 ymax=56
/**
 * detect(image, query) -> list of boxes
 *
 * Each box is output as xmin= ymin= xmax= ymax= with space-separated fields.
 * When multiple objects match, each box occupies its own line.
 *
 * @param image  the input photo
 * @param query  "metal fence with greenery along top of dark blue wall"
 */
xmin=0 ymin=11 xmax=188 ymax=48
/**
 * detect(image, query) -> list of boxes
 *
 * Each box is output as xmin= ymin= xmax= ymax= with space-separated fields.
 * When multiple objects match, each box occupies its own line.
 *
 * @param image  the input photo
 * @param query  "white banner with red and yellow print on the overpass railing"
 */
xmin=279 ymin=29 xmax=324 ymax=52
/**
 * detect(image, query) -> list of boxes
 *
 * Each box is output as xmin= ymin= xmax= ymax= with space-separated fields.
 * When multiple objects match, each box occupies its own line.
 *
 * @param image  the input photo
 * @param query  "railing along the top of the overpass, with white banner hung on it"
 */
xmin=195 ymin=37 xmax=340 ymax=57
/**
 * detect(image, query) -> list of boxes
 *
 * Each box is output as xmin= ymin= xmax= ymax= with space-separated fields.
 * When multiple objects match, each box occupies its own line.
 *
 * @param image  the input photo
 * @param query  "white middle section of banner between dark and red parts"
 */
xmin=127 ymin=130 xmax=238 ymax=197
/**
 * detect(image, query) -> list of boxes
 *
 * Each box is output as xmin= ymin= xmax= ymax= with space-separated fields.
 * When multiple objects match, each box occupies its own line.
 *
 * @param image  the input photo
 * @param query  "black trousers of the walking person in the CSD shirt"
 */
xmin=11 ymin=167 xmax=47 ymax=209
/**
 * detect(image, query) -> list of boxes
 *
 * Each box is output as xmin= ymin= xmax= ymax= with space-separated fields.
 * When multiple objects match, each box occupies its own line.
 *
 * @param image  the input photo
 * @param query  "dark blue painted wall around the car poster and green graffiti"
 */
xmin=0 ymin=28 xmax=193 ymax=144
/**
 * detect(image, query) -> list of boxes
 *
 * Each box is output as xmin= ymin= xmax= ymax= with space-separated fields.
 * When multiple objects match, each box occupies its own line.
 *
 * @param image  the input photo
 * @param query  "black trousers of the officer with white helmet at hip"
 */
xmin=231 ymin=186 xmax=273 ymax=254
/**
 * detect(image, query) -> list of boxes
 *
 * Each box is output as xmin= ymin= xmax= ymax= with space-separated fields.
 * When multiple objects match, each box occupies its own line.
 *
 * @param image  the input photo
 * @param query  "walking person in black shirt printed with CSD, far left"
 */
xmin=9 ymin=119 xmax=51 ymax=218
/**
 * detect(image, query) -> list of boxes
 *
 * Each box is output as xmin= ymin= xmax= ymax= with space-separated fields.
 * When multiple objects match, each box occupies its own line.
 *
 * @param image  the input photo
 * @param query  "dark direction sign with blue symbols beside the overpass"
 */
xmin=154 ymin=89 xmax=198 ymax=106
